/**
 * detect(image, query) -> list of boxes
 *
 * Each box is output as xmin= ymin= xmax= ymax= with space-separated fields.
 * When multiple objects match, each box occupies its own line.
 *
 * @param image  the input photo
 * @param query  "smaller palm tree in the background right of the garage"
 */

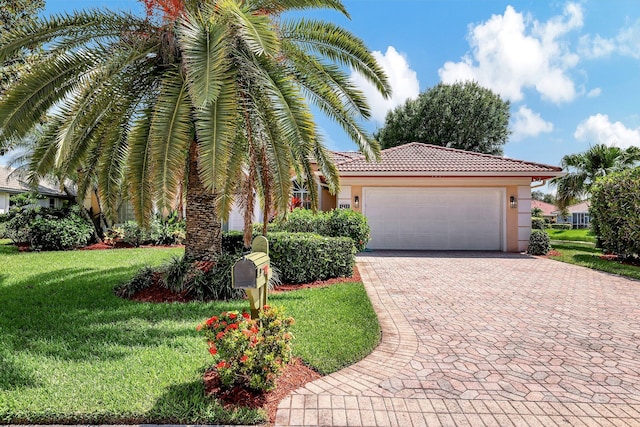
xmin=551 ymin=144 xmax=640 ymax=210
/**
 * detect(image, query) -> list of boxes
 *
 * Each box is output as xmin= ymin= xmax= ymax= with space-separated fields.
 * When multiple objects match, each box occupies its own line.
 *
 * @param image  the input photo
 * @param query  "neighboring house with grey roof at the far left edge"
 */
xmin=0 ymin=166 xmax=75 ymax=214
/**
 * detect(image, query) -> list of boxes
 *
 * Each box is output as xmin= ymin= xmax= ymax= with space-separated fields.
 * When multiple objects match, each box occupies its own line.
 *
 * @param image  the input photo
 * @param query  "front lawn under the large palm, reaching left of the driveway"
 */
xmin=0 ymin=246 xmax=380 ymax=424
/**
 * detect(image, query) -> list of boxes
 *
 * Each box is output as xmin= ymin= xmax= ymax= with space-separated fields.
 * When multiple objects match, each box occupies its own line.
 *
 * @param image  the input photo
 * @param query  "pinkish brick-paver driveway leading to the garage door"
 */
xmin=276 ymin=252 xmax=640 ymax=427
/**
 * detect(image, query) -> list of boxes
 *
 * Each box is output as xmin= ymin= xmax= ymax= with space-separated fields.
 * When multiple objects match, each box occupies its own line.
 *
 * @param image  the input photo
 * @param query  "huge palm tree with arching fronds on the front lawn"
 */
xmin=0 ymin=0 xmax=390 ymax=259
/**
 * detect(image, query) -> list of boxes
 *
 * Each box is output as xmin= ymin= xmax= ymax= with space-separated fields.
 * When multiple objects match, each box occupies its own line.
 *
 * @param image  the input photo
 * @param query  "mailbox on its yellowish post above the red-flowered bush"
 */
xmin=231 ymin=236 xmax=272 ymax=319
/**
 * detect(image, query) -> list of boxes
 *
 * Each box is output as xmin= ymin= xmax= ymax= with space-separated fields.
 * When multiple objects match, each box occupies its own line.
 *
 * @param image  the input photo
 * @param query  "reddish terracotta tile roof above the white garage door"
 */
xmin=336 ymin=142 xmax=562 ymax=178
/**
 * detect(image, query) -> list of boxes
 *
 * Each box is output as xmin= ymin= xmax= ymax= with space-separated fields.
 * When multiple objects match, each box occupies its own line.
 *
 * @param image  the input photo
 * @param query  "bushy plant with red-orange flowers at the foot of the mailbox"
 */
xmin=197 ymin=305 xmax=294 ymax=390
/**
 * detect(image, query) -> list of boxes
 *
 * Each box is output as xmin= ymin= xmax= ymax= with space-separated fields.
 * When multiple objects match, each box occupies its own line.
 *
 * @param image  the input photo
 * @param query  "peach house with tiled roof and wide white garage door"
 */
xmin=312 ymin=143 xmax=563 ymax=252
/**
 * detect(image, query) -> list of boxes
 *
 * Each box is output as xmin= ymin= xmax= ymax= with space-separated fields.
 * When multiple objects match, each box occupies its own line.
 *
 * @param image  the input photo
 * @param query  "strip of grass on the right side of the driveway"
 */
xmin=550 ymin=243 xmax=640 ymax=280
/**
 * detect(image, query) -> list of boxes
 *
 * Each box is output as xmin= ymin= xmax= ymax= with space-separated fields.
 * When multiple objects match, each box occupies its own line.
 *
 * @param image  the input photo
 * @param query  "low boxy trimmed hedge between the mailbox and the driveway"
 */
xmin=269 ymin=232 xmax=356 ymax=283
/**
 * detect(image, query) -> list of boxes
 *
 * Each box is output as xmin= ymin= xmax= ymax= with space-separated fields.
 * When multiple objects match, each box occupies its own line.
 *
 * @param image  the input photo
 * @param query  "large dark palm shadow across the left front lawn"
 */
xmin=0 ymin=265 xmax=218 ymax=390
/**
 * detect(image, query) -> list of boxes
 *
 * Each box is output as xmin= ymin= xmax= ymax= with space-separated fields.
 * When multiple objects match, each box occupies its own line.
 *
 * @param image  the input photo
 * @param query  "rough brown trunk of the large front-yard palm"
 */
xmin=184 ymin=141 xmax=222 ymax=261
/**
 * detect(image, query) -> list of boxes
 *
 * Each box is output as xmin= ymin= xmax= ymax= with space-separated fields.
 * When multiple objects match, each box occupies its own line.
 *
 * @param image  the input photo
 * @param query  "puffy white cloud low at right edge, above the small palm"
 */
xmin=573 ymin=114 xmax=640 ymax=148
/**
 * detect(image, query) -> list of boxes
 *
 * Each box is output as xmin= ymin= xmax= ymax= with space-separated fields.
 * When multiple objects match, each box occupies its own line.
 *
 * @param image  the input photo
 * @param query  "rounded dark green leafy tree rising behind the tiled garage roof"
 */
xmin=374 ymin=82 xmax=510 ymax=155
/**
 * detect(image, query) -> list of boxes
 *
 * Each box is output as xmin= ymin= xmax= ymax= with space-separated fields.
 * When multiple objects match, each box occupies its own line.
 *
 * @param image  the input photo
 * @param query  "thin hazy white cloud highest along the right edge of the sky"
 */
xmin=580 ymin=19 xmax=640 ymax=59
